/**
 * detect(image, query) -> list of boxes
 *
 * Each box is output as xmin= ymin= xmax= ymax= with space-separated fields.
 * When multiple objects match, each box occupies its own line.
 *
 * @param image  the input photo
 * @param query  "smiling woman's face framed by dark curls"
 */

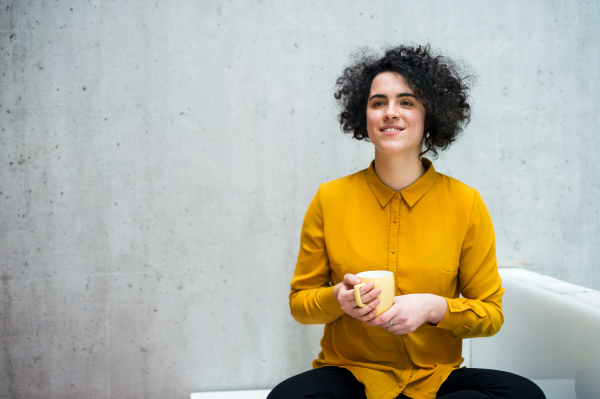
xmin=367 ymin=72 xmax=425 ymax=157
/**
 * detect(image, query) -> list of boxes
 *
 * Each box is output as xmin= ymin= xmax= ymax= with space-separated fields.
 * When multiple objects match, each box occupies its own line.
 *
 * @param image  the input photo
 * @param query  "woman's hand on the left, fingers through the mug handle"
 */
xmin=333 ymin=274 xmax=381 ymax=322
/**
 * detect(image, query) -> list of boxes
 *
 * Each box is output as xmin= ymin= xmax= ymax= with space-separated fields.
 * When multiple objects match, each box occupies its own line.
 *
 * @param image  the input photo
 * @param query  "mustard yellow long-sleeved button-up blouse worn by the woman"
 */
xmin=290 ymin=159 xmax=504 ymax=399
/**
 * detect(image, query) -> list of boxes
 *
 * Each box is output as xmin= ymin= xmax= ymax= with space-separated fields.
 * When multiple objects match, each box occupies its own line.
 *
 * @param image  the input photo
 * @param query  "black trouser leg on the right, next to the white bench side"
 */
xmin=437 ymin=368 xmax=546 ymax=399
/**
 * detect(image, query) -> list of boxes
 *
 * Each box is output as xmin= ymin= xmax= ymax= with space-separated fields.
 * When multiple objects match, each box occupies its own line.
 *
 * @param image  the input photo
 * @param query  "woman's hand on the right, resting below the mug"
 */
xmin=367 ymin=294 xmax=448 ymax=335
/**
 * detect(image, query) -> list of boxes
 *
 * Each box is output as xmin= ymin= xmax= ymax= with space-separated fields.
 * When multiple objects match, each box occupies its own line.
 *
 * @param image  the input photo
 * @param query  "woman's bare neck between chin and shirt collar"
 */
xmin=375 ymin=149 xmax=426 ymax=191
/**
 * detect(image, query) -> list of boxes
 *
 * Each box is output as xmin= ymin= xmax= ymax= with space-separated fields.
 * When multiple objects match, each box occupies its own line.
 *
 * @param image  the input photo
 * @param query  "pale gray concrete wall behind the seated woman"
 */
xmin=0 ymin=0 xmax=600 ymax=398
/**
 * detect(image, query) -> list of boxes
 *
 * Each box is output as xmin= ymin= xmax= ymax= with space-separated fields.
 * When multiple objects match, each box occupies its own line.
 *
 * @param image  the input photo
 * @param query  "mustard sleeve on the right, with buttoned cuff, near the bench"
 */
xmin=437 ymin=192 xmax=504 ymax=338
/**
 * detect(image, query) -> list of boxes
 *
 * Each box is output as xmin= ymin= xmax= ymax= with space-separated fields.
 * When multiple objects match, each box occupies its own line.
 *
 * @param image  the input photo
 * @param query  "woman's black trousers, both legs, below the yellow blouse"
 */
xmin=267 ymin=366 xmax=546 ymax=399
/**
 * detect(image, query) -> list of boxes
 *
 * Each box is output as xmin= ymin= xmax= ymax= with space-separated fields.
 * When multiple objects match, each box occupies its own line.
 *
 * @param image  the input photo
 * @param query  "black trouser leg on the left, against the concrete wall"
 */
xmin=267 ymin=366 xmax=367 ymax=399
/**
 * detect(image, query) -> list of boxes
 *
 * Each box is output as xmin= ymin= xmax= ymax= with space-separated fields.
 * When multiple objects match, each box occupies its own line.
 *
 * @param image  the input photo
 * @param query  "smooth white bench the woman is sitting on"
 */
xmin=191 ymin=268 xmax=600 ymax=399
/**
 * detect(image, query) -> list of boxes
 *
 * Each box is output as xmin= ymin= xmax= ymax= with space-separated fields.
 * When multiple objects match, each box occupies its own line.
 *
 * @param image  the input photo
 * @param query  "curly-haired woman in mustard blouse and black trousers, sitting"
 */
xmin=269 ymin=46 xmax=544 ymax=399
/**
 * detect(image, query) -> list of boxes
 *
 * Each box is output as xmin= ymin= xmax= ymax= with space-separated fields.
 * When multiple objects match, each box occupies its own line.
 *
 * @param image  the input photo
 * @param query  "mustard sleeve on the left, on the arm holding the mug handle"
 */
xmin=290 ymin=190 xmax=345 ymax=324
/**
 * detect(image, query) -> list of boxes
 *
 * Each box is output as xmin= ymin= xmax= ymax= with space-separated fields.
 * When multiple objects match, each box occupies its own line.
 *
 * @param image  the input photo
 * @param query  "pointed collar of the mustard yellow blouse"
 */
xmin=367 ymin=158 xmax=437 ymax=208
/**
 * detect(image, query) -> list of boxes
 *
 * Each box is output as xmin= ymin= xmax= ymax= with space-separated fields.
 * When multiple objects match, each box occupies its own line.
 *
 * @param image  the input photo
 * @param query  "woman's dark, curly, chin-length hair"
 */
xmin=334 ymin=45 xmax=474 ymax=157
